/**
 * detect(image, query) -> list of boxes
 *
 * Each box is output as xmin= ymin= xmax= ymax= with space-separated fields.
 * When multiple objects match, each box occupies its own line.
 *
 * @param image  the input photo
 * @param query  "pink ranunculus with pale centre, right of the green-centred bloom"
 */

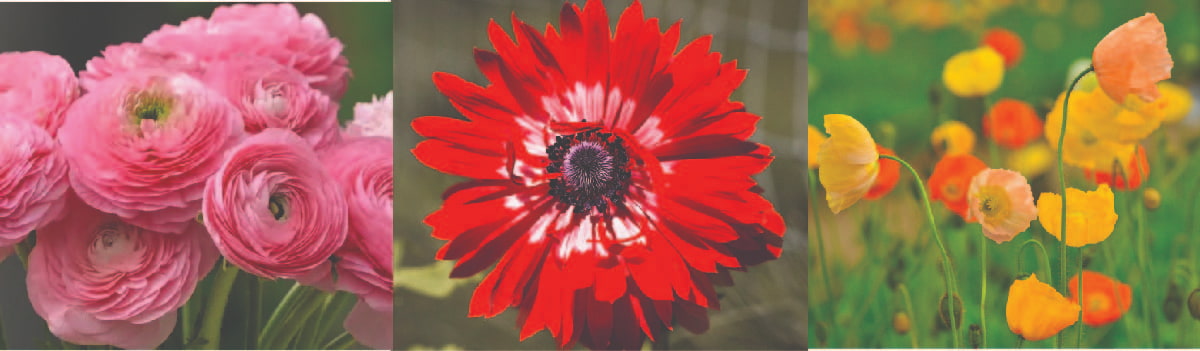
xmin=204 ymin=58 xmax=341 ymax=149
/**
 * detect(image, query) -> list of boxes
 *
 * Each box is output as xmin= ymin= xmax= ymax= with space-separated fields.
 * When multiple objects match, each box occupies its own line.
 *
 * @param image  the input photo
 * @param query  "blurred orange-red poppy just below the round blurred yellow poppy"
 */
xmin=983 ymin=99 xmax=1042 ymax=150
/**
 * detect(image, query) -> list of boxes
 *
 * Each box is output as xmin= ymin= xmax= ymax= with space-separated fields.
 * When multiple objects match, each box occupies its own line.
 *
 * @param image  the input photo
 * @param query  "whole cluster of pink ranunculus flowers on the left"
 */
xmin=0 ymin=4 xmax=392 ymax=349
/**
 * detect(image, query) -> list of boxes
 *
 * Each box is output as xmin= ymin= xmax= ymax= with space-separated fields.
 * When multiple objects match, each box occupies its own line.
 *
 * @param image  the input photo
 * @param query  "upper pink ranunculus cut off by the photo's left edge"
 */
xmin=0 ymin=52 xmax=79 ymax=137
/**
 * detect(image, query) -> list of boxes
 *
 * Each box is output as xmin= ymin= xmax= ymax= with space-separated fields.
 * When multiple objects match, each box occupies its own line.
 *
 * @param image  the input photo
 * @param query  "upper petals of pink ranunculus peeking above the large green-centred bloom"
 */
xmin=79 ymin=43 xmax=203 ymax=91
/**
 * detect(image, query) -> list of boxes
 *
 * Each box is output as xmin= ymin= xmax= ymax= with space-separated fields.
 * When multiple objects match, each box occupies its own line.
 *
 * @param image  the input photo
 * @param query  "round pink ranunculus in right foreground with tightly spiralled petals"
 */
xmin=204 ymin=129 xmax=348 ymax=281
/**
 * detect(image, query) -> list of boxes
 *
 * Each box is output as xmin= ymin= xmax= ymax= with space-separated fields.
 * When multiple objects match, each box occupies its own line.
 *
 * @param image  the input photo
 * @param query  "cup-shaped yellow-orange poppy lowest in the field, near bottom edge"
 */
xmin=1004 ymin=274 xmax=1086 ymax=341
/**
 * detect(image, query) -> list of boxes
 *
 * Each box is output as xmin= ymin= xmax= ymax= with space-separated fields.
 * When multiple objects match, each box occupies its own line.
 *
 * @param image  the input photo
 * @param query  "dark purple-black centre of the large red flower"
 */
xmin=546 ymin=130 xmax=629 ymax=213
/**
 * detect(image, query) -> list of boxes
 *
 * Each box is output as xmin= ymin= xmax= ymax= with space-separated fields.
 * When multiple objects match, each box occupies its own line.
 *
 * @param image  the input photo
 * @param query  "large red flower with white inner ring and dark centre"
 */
xmin=413 ymin=1 xmax=785 ymax=349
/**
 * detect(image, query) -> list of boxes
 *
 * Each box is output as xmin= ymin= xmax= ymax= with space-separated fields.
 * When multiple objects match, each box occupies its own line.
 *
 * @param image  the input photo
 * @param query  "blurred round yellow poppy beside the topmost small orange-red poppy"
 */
xmin=942 ymin=46 xmax=1004 ymax=97
